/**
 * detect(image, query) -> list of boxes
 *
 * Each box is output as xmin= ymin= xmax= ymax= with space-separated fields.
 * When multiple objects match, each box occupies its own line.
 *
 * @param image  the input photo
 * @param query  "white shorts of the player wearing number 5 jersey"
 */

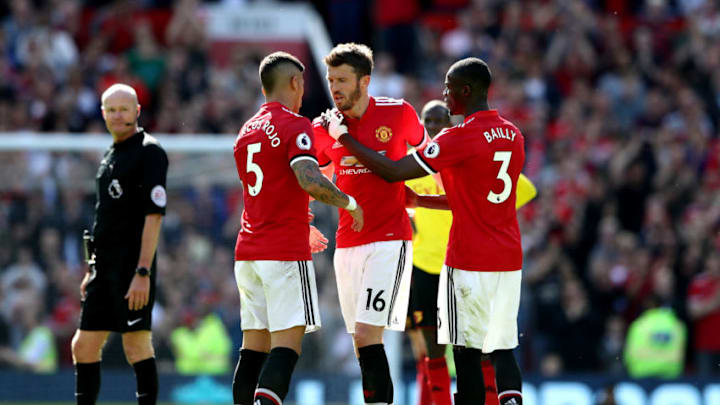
xmin=235 ymin=260 xmax=321 ymax=333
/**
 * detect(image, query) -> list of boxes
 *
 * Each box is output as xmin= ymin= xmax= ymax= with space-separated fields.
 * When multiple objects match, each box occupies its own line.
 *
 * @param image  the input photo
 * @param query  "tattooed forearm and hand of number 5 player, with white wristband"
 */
xmin=291 ymin=159 xmax=363 ymax=231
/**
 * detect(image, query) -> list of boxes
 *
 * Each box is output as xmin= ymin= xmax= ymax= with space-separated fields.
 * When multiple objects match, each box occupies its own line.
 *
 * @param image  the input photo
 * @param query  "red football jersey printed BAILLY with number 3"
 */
xmin=413 ymin=110 xmax=525 ymax=271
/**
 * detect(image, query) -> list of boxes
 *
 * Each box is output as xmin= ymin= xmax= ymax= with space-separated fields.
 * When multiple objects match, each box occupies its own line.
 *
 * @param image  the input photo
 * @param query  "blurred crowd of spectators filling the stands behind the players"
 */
xmin=0 ymin=0 xmax=720 ymax=376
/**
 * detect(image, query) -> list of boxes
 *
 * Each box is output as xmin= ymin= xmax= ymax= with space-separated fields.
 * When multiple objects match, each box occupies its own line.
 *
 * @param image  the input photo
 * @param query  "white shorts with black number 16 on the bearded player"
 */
xmin=333 ymin=240 xmax=412 ymax=333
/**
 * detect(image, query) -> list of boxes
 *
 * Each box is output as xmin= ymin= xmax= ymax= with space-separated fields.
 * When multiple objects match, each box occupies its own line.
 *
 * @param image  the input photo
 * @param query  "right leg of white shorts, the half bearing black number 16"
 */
xmin=355 ymin=241 xmax=412 ymax=331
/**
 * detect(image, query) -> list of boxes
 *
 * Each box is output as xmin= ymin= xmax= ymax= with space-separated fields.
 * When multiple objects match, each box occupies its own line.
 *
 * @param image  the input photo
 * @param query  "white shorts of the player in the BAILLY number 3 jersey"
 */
xmin=438 ymin=266 xmax=522 ymax=353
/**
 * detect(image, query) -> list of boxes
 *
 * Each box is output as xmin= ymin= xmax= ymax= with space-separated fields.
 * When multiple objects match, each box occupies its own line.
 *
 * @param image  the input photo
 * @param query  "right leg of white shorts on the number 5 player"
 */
xmin=256 ymin=260 xmax=321 ymax=333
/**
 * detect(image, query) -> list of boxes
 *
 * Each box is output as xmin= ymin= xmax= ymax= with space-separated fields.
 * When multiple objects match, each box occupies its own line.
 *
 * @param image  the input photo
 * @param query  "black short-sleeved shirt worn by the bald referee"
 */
xmin=93 ymin=129 xmax=168 ymax=249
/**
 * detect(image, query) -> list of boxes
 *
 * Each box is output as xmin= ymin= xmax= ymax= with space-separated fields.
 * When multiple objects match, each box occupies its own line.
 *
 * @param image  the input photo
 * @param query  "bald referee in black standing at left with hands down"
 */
xmin=72 ymin=84 xmax=168 ymax=405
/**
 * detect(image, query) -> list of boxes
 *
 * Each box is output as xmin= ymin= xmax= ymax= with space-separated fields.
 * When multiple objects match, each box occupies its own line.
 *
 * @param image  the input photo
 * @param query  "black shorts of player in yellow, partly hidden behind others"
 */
xmin=406 ymin=266 xmax=440 ymax=329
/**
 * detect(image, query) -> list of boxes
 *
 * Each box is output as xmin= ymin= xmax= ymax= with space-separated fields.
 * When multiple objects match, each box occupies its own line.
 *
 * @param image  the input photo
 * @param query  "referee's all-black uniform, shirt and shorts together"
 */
xmin=80 ymin=128 xmax=168 ymax=333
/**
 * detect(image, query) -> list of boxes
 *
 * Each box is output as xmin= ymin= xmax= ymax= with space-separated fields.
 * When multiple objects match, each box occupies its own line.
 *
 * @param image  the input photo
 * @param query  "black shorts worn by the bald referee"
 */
xmin=80 ymin=251 xmax=156 ymax=333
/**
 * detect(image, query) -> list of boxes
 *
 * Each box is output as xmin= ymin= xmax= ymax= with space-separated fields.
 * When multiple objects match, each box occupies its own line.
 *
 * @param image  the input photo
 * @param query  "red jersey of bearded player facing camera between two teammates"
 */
xmin=313 ymin=97 xmax=426 ymax=248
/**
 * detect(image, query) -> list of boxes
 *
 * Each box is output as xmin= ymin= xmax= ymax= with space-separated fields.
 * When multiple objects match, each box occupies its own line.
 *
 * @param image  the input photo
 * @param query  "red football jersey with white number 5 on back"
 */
xmin=234 ymin=102 xmax=317 ymax=261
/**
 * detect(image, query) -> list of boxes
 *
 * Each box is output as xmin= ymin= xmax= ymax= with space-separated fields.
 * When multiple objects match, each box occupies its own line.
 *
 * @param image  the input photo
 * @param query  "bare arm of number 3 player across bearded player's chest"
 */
xmin=338 ymin=133 xmax=427 ymax=183
